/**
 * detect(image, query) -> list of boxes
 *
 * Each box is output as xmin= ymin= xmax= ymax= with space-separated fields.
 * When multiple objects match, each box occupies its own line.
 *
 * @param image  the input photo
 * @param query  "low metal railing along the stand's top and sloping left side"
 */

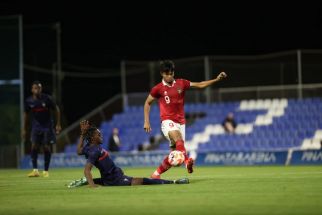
xmin=57 ymin=83 xmax=322 ymax=151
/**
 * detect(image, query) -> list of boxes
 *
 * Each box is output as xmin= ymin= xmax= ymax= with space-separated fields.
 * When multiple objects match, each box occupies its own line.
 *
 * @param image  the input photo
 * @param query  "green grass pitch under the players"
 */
xmin=0 ymin=166 xmax=322 ymax=215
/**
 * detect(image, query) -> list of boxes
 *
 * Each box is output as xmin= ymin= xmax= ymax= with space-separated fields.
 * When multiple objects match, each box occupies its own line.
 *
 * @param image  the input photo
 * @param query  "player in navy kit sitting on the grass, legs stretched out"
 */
xmin=68 ymin=120 xmax=189 ymax=188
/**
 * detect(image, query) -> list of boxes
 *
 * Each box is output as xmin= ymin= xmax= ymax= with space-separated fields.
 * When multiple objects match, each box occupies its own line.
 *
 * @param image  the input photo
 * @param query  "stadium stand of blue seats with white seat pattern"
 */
xmin=65 ymin=98 xmax=322 ymax=152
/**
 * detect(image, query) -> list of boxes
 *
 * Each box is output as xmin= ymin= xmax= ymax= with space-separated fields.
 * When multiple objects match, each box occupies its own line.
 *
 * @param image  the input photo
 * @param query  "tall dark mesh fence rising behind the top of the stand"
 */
xmin=121 ymin=50 xmax=322 ymax=102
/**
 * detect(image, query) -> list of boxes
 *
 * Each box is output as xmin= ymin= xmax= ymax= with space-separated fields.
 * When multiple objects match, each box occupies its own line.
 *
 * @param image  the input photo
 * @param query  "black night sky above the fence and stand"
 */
xmin=0 ymin=1 xmax=322 ymax=124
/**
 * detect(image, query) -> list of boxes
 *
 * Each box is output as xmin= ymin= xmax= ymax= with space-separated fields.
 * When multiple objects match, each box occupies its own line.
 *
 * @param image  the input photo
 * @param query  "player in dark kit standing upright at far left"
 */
xmin=22 ymin=81 xmax=61 ymax=177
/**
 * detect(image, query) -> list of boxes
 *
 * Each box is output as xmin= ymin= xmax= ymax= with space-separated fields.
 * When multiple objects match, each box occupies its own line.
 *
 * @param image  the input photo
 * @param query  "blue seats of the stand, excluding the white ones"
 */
xmin=65 ymin=98 xmax=322 ymax=153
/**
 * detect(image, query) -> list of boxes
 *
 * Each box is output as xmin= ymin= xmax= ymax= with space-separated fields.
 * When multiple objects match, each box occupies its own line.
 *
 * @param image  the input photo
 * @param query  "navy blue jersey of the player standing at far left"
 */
xmin=25 ymin=93 xmax=56 ymax=131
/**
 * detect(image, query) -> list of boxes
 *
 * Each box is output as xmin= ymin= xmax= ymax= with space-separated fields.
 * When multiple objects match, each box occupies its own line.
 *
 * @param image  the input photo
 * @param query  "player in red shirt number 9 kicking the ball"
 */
xmin=144 ymin=60 xmax=227 ymax=178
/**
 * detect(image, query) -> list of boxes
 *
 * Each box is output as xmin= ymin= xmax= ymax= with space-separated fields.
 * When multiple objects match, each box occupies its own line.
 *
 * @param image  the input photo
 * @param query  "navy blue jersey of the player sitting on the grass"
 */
xmin=83 ymin=144 xmax=124 ymax=185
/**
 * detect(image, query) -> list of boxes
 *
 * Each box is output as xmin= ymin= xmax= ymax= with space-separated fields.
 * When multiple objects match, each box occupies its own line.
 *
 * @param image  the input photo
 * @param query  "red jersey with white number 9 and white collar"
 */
xmin=150 ymin=79 xmax=190 ymax=124
